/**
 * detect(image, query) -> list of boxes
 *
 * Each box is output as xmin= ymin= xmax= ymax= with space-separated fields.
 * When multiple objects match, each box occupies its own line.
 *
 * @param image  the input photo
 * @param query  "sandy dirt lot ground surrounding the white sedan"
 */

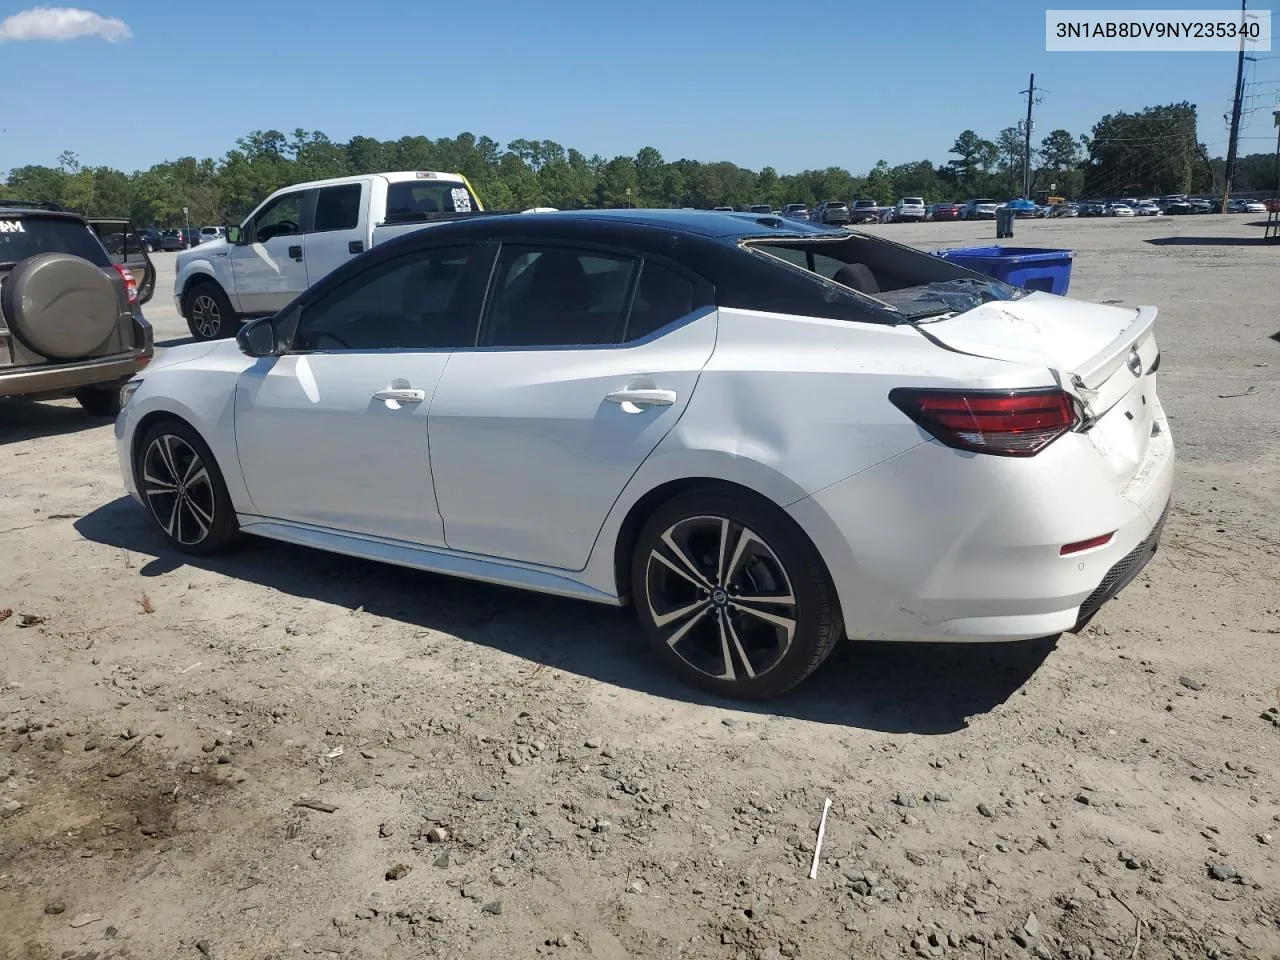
xmin=0 ymin=216 xmax=1280 ymax=960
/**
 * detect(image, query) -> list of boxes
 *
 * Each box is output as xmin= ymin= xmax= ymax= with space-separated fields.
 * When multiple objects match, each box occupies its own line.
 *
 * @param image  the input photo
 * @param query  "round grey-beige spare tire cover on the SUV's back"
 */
xmin=0 ymin=253 xmax=120 ymax=360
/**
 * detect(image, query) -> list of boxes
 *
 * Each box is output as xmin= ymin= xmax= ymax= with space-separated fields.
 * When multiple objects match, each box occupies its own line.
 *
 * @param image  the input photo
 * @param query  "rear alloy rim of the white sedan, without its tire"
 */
xmin=645 ymin=516 xmax=799 ymax=681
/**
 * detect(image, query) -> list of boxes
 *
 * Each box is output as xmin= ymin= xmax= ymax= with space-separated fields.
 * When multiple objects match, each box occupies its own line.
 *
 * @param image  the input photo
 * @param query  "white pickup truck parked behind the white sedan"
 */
xmin=173 ymin=170 xmax=484 ymax=340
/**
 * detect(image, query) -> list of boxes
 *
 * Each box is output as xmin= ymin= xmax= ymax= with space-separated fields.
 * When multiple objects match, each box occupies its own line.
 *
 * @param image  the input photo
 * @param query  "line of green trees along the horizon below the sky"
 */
xmin=0 ymin=102 xmax=1228 ymax=227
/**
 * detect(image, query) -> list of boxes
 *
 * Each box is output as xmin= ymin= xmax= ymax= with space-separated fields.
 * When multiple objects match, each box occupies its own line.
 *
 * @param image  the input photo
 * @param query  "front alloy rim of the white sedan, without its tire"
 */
xmin=141 ymin=434 xmax=216 ymax=547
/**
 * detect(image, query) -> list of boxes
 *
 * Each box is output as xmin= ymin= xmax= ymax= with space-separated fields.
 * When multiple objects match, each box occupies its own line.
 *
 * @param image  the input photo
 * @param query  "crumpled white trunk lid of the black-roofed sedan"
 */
xmin=915 ymin=293 xmax=1160 ymax=483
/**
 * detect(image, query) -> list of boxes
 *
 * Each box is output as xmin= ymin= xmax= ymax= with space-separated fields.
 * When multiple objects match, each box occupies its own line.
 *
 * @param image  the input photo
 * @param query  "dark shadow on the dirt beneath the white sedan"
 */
xmin=76 ymin=498 xmax=1056 ymax=735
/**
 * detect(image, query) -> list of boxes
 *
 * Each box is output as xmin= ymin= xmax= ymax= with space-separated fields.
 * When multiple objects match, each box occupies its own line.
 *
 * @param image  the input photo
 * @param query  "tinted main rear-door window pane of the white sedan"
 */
xmin=481 ymin=244 xmax=639 ymax=348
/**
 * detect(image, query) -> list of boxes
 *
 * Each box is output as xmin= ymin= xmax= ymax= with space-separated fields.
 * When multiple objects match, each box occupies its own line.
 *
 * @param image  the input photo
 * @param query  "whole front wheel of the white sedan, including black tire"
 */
xmin=133 ymin=420 xmax=239 ymax=557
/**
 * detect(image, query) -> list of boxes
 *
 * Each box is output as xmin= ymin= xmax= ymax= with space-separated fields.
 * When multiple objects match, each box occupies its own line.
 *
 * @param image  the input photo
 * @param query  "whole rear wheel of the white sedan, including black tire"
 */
xmin=631 ymin=489 xmax=844 ymax=700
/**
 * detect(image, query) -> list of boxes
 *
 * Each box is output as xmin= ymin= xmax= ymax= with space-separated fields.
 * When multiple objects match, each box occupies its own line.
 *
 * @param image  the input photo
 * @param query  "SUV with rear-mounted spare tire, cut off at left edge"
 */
xmin=0 ymin=201 xmax=155 ymax=416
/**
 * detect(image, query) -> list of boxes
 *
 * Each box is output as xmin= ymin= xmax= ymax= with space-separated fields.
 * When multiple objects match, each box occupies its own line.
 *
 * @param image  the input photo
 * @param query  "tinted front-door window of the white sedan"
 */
xmin=293 ymin=247 xmax=477 ymax=352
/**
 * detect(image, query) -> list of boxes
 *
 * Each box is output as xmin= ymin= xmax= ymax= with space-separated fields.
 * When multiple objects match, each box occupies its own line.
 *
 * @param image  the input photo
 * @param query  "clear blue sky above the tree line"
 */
xmin=0 ymin=0 xmax=1280 ymax=173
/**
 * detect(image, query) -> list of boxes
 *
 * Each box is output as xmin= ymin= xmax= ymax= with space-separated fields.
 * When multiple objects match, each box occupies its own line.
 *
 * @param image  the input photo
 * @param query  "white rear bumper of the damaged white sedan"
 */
xmin=788 ymin=399 xmax=1174 ymax=643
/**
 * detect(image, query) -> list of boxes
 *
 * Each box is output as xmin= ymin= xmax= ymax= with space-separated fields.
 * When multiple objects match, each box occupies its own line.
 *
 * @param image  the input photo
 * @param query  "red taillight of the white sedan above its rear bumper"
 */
xmin=888 ymin=388 xmax=1076 ymax=457
